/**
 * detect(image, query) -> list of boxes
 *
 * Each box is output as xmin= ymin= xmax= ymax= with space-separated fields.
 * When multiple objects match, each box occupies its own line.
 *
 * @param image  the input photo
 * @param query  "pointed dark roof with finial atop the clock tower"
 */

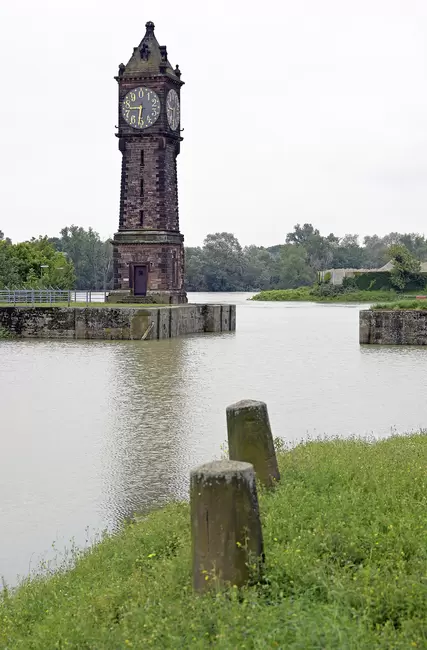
xmin=119 ymin=21 xmax=181 ymax=81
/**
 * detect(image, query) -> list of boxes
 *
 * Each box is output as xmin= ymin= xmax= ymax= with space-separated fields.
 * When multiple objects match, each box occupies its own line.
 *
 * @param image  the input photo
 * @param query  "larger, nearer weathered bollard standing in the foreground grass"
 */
xmin=190 ymin=460 xmax=263 ymax=591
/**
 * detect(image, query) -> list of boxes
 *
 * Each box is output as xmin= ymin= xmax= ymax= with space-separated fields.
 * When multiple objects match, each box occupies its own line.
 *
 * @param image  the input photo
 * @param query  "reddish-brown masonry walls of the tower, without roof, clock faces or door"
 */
xmin=113 ymin=74 xmax=184 ymax=292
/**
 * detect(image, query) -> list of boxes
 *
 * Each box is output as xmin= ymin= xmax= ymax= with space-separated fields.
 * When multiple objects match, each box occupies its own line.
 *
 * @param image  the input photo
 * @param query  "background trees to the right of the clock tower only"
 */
xmin=186 ymin=224 xmax=427 ymax=291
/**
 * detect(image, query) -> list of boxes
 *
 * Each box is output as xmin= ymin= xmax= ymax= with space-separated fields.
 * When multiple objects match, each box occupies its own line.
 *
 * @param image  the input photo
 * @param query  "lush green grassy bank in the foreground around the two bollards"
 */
xmin=0 ymin=435 xmax=427 ymax=650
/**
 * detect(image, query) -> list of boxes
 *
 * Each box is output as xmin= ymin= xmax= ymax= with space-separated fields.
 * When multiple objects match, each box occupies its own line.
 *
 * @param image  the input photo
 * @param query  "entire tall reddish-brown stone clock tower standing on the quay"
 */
xmin=109 ymin=22 xmax=187 ymax=304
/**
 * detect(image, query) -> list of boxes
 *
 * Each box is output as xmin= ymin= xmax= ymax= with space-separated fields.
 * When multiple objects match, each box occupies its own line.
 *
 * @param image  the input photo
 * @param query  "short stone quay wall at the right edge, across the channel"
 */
xmin=359 ymin=309 xmax=427 ymax=345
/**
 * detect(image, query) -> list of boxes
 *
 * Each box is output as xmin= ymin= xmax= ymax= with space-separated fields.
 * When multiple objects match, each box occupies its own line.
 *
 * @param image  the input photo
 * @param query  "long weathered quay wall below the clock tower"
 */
xmin=0 ymin=304 xmax=236 ymax=340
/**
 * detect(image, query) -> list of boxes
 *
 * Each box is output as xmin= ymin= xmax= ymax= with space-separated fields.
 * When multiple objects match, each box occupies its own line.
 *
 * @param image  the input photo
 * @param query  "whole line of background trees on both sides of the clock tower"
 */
xmin=0 ymin=224 xmax=427 ymax=291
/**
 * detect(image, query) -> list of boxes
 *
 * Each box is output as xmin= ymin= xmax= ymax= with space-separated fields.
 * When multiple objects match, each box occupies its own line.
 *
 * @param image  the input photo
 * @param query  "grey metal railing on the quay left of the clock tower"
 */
xmin=0 ymin=289 xmax=108 ymax=305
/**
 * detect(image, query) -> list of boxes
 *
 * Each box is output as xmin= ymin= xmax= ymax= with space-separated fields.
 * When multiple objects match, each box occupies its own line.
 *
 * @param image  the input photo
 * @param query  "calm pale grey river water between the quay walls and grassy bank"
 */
xmin=0 ymin=294 xmax=427 ymax=582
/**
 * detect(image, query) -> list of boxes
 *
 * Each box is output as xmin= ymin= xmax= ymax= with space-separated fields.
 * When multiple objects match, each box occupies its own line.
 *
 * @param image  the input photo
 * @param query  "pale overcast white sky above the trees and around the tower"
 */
xmin=0 ymin=0 xmax=427 ymax=246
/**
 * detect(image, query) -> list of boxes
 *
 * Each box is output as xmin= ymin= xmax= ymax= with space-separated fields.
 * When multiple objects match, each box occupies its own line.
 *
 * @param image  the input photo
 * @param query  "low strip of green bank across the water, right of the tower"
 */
xmin=251 ymin=285 xmax=422 ymax=302
